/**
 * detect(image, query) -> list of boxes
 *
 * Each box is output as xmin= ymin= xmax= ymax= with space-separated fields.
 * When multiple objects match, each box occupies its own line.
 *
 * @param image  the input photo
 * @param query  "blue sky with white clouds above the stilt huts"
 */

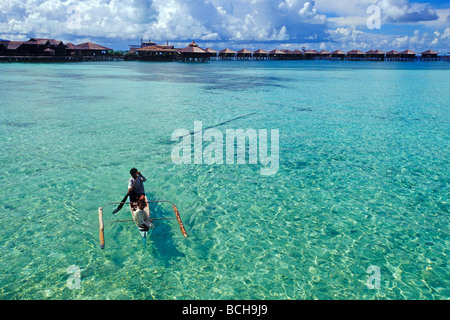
xmin=0 ymin=0 xmax=450 ymax=52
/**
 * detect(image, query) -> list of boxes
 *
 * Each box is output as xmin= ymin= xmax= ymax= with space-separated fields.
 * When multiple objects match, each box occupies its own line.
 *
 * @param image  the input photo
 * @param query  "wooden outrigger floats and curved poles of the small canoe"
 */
xmin=98 ymin=198 xmax=187 ymax=249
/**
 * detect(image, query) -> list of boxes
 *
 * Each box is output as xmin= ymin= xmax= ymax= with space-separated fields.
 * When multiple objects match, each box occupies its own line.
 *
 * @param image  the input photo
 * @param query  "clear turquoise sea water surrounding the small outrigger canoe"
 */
xmin=0 ymin=61 xmax=450 ymax=299
